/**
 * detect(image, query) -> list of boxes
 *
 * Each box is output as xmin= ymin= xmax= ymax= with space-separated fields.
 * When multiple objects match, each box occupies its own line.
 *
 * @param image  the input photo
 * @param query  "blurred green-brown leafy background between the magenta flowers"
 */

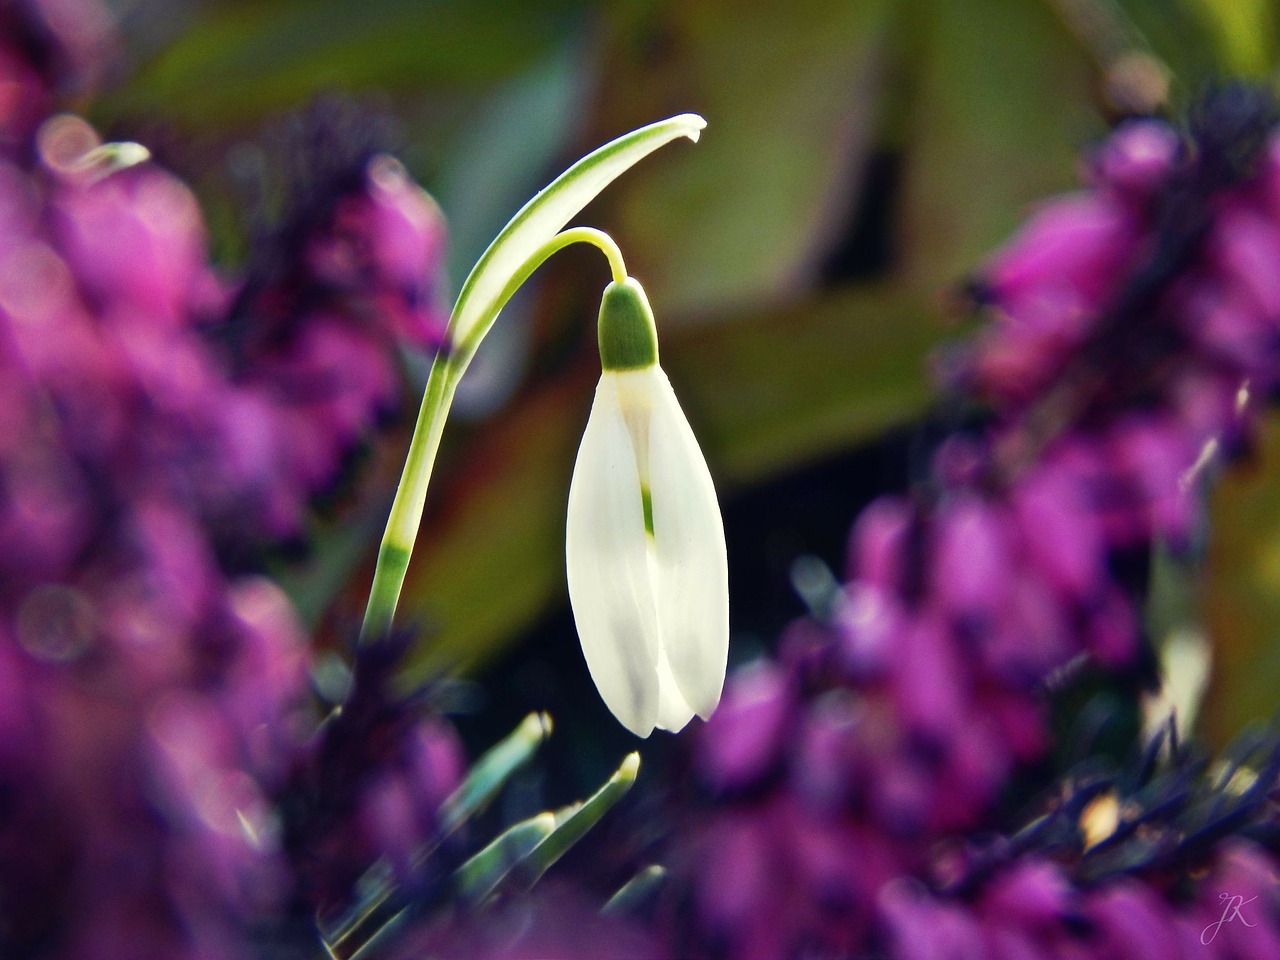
xmin=94 ymin=0 xmax=1280 ymax=798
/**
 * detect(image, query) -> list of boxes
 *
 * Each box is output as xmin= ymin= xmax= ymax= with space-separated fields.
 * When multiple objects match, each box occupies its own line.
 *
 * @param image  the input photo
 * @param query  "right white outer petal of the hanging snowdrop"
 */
xmin=646 ymin=367 xmax=728 ymax=730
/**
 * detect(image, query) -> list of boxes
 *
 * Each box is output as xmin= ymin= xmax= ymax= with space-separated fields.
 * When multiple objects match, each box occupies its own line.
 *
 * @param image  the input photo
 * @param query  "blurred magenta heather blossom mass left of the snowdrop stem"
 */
xmin=0 ymin=1 xmax=461 ymax=960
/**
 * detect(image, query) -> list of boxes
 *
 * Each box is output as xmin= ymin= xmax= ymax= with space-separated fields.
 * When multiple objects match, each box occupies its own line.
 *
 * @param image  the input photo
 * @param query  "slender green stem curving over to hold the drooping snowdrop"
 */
xmin=360 ymin=227 xmax=627 ymax=643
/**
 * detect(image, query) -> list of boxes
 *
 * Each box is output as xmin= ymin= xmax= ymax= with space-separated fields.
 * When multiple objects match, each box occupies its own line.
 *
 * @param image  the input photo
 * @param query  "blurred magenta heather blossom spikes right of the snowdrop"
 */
xmin=672 ymin=88 xmax=1280 ymax=960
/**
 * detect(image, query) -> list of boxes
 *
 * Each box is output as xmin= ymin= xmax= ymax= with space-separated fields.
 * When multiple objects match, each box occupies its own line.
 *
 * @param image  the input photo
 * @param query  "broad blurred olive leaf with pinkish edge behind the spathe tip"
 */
xmin=586 ymin=0 xmax=892 ymax=323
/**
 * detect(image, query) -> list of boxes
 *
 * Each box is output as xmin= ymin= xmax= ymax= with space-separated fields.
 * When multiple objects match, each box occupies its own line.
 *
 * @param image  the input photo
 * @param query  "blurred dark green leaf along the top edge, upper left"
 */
xmin=116 ymin=0 xmax=581 ymax=124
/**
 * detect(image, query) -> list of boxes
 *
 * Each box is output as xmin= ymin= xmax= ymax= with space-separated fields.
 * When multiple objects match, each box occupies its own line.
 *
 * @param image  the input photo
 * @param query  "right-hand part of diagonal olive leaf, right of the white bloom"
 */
xmin=659 ymin=285 xmax=954 ymax=483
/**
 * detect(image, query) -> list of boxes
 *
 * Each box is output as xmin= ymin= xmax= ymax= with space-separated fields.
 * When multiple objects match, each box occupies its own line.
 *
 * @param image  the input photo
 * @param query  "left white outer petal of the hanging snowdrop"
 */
xmin=564 ymin=374 xmax=659 ymax=737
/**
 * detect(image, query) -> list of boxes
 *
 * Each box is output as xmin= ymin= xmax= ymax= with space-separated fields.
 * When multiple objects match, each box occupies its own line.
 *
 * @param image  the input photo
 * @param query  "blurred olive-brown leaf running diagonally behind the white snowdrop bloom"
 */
xmin=401 ymin=281 xmax=943 ymax=672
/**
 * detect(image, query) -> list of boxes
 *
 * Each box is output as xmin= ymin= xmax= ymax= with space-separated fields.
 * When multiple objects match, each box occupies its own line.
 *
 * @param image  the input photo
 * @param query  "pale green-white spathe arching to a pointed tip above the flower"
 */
xmin=449 ymin=114 xmax=707 ymax=344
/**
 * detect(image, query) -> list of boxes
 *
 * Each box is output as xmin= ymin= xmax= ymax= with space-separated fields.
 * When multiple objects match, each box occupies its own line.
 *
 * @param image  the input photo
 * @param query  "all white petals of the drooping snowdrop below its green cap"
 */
xmin=564 ymin=364 xmax=728 ymax=737
